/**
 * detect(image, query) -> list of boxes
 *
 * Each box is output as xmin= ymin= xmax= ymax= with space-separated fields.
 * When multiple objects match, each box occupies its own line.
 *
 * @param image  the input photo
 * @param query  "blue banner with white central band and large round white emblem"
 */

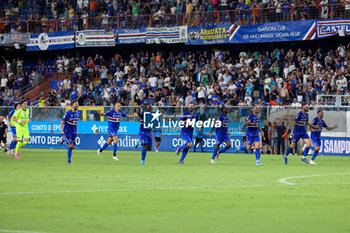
xmin=27 ymin=31 xmax=75 ymax=51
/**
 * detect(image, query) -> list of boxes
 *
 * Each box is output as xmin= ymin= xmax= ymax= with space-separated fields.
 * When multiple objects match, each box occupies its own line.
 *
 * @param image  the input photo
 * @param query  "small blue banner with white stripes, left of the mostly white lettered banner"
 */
xmin=116 ymin=28 xmax=146 ymax=44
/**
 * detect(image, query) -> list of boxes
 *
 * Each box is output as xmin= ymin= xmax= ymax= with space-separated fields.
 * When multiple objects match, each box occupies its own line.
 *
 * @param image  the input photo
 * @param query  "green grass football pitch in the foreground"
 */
xmin=0 ymin=149 xmax=350 ymax=233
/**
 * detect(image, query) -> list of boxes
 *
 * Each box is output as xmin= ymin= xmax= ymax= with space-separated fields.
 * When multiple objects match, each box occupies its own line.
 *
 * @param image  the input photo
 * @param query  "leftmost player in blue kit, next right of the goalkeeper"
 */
xmin=61 ymin=100 xmax=80 ymax=164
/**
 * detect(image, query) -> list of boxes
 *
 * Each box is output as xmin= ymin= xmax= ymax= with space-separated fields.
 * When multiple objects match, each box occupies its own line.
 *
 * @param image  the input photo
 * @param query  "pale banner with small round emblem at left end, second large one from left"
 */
xmin=75 ymin=30 xmax=115 ymax=47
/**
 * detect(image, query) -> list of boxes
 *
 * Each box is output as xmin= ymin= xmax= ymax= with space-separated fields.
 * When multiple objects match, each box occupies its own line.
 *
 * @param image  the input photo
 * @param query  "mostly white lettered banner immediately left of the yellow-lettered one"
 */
xmin=146 ymin=26 xmax=187 ymax=44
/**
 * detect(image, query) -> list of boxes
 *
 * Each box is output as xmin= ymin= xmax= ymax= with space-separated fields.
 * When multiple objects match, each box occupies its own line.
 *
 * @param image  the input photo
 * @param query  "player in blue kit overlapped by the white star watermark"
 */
xmin=139 ymin=104 xmax=153 ymax=165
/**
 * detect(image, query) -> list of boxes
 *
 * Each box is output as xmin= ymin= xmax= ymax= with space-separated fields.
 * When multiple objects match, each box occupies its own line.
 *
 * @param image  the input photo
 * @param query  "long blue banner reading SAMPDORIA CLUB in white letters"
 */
xmin=229 ymin=20 xmax=316 ymax=44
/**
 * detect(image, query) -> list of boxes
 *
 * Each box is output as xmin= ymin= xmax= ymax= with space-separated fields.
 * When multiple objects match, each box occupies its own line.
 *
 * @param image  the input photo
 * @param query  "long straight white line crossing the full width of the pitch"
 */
xmin=0 ymin=181 xmax=350 ymax=196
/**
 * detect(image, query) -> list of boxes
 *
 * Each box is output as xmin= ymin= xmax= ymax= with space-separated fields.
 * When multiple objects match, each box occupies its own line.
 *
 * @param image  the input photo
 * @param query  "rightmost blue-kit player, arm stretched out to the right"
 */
xmin=309 ymin=110 xmax=338 ymax=164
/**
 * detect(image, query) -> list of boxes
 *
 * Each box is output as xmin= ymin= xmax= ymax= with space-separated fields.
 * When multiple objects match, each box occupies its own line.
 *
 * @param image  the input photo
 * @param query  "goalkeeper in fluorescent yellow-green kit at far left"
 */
xmin=13 ymin=101 xmax=30 ymax=159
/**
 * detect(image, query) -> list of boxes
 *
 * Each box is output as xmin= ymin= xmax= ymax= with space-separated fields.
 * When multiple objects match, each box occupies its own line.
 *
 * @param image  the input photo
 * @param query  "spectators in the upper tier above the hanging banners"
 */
xmin=0 ymin=0 xmax=350 ymax=32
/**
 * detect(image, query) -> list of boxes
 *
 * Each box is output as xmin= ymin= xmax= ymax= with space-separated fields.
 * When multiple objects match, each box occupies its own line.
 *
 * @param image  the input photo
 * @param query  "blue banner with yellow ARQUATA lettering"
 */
xmin=186 ymin=24 xmax=239 ymax=45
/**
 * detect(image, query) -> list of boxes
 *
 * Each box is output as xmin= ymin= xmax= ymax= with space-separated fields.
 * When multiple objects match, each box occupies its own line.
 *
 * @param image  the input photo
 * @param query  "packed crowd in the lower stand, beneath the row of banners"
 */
xmin=0 ymin=44 xmax=350 ymax=107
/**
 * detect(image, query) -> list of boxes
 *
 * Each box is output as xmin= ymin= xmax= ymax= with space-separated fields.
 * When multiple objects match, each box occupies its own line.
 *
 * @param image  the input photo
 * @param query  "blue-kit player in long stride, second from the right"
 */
xmin=283 ymin=103 xmax=318 ymax=164
